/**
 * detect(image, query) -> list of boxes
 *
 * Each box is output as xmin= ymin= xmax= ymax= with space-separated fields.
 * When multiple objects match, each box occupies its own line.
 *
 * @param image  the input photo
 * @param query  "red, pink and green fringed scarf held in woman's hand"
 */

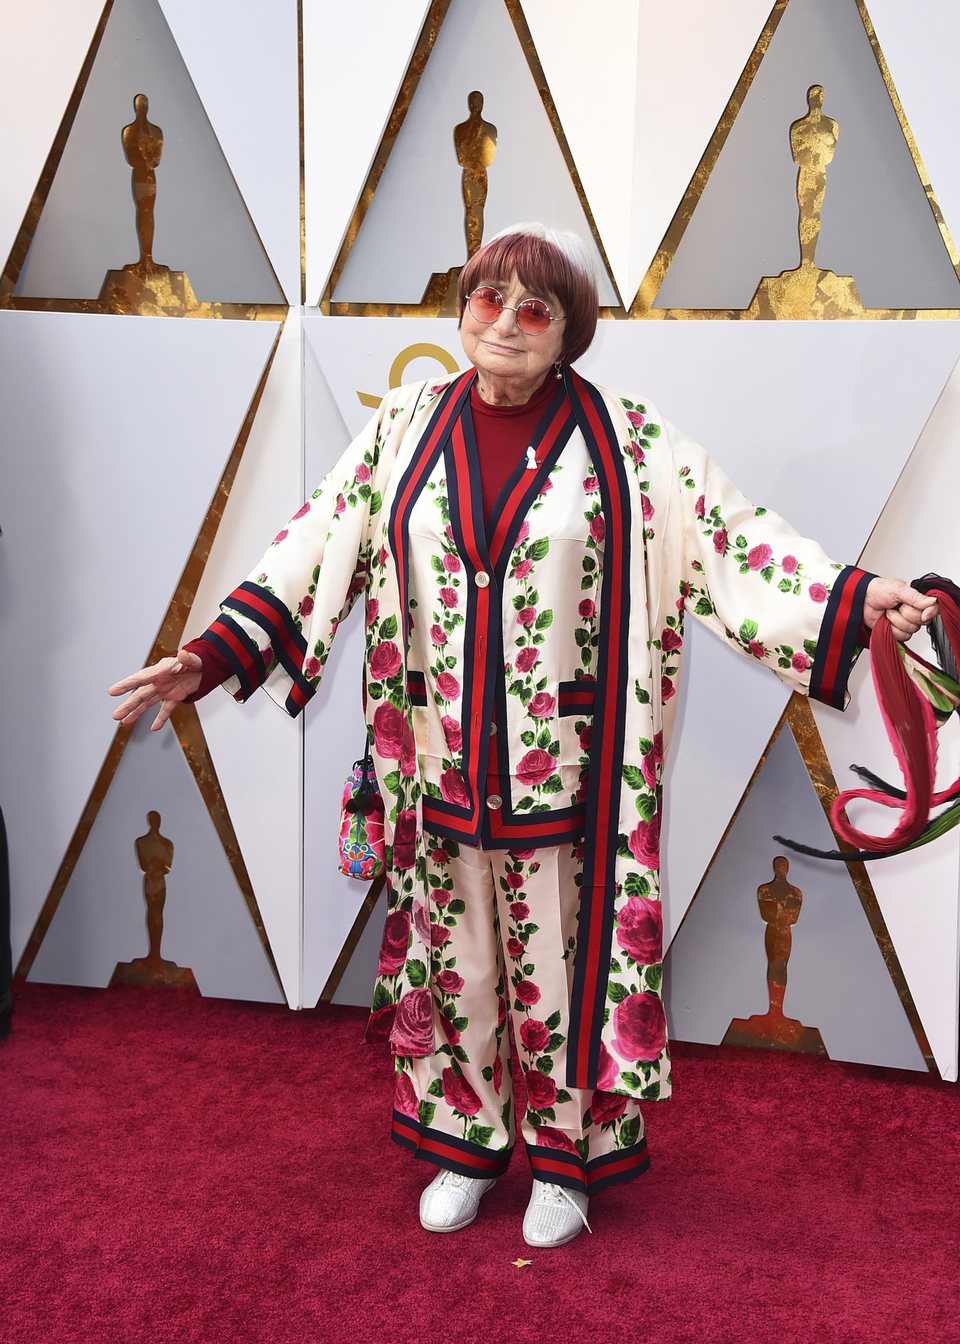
xmin=773 ymin=574 xmax=960 ymax=863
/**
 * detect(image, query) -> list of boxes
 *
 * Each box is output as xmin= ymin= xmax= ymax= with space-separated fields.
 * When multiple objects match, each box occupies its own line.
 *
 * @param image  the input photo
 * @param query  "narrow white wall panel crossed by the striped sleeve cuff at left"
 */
xmin=186 ymin=313 xmax=303 ymax=1007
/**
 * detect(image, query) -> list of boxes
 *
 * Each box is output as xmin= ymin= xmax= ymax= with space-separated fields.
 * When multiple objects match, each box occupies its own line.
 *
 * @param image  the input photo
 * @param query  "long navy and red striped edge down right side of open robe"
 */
xmin=566 ymin=370 xmax=632 ymax=1087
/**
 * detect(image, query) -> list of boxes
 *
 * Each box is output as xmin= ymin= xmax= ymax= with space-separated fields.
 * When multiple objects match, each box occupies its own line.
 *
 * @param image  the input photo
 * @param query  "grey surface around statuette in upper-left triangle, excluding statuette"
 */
xmin=16 ymin=0 xmax=282 ymax=302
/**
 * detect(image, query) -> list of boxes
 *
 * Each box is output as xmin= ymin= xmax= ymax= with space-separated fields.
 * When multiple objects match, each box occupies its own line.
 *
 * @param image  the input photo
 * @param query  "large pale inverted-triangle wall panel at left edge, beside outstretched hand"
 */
xmin=0 ymin=312 xmax=276 ymax=960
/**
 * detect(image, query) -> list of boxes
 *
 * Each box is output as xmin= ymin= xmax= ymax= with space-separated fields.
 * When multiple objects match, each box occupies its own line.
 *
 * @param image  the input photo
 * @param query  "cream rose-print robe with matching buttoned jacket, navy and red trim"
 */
xmin=206 ymin=370 xmax=871 ymax=1098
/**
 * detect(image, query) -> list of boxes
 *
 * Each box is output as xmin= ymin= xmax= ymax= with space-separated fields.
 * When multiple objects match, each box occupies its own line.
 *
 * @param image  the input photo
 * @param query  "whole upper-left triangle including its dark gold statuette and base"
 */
xmin=4 ymin=0 xmax=284 ymax=316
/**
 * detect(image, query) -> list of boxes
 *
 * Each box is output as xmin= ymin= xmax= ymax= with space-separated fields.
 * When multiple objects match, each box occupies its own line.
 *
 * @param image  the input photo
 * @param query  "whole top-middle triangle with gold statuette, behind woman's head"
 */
xmin=323 ymin=0 xmax=618 ymax=316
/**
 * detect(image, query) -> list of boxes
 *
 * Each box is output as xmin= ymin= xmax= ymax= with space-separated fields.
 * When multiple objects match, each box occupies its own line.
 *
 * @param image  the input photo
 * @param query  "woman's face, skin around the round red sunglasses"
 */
xmin=460 ymin=276 xmax=565 ymax=387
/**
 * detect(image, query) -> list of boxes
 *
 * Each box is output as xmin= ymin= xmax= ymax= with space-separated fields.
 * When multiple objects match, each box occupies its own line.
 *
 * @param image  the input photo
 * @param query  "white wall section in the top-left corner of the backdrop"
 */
xmin=0 ymin=0 xmax=104 ymax=269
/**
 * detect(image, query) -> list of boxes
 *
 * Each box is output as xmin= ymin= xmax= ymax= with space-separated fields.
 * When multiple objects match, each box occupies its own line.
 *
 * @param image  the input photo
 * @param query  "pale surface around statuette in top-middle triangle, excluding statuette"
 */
xmin=333 ymin=0 xmax=616 ymax=304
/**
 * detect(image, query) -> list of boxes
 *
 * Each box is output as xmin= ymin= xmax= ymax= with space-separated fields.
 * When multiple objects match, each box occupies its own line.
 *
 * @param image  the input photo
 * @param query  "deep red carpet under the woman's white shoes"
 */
xmin=0 ymin=985 xmax=960 ymax=1344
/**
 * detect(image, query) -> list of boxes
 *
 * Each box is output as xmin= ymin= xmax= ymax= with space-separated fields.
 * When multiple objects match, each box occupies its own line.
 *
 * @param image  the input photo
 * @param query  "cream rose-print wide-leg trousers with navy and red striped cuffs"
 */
xmin=393 ymin=840 xmax=649 ymax=1193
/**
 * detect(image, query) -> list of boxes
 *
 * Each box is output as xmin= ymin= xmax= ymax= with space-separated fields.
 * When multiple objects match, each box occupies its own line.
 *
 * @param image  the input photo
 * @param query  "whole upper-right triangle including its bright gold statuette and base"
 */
xmin=655 ymin=0 xmax=960 ymax=319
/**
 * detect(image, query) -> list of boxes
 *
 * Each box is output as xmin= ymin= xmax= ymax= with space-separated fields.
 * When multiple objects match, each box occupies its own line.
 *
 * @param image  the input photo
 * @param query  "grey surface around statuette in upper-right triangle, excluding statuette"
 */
xmin=656 ymin=0 xmax=960 ymax=309
